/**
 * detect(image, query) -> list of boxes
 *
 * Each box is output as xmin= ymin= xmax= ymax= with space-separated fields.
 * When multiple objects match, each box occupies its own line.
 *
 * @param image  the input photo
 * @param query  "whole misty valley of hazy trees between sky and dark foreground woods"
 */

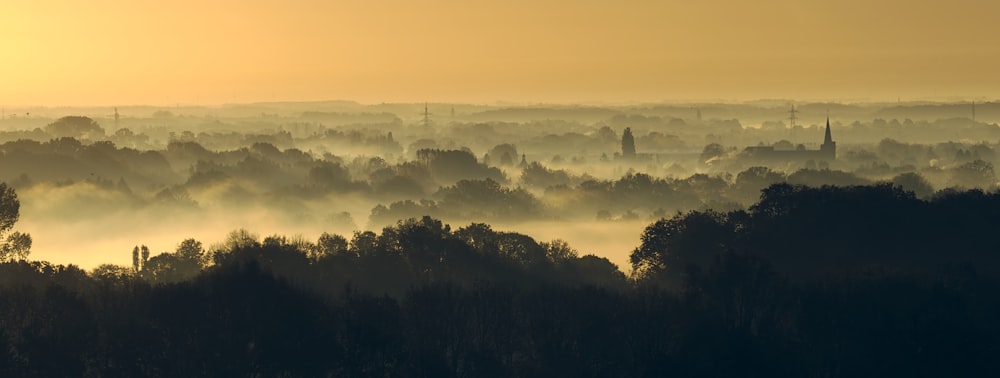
xmin=0 ymin=102 xmax=1000 ymax=270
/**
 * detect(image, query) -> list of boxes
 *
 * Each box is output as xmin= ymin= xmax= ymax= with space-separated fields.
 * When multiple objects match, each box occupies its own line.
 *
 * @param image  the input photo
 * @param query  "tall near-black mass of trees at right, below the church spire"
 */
xmin=630 ymin=184 xmax=1000 ymax=288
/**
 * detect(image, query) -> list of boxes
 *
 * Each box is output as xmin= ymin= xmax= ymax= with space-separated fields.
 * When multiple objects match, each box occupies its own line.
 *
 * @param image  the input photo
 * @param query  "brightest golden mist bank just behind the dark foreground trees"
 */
xmin=18 ymin=176 xmax=648 ymax=269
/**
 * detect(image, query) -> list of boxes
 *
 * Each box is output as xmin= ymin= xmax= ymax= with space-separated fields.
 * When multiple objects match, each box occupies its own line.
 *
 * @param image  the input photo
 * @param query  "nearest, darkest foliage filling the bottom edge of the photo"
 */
xmin=0 ymin=255 xmax=1000 ymax=377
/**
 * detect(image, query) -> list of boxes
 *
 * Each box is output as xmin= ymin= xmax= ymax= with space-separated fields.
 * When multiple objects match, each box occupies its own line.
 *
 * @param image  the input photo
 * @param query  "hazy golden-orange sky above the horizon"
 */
xmin=0 ymin=0 xmax=1000 ymax=107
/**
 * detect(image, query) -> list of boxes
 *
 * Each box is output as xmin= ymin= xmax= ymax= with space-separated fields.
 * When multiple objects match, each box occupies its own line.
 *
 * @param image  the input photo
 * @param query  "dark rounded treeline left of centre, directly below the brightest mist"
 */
xmin=115 ymin=216 xmax=628 ymax=296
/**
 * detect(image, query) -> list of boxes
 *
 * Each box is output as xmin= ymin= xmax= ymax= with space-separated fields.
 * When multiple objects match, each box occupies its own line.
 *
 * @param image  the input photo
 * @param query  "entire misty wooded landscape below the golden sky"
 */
xmin=0 ymin=104 xmax=1000 ymax=376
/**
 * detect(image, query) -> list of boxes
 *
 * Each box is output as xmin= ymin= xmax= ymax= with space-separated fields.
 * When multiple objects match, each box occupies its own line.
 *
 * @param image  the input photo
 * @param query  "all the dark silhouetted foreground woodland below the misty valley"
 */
xmin=0 ymin=186 xmax=1000 ymax=377
